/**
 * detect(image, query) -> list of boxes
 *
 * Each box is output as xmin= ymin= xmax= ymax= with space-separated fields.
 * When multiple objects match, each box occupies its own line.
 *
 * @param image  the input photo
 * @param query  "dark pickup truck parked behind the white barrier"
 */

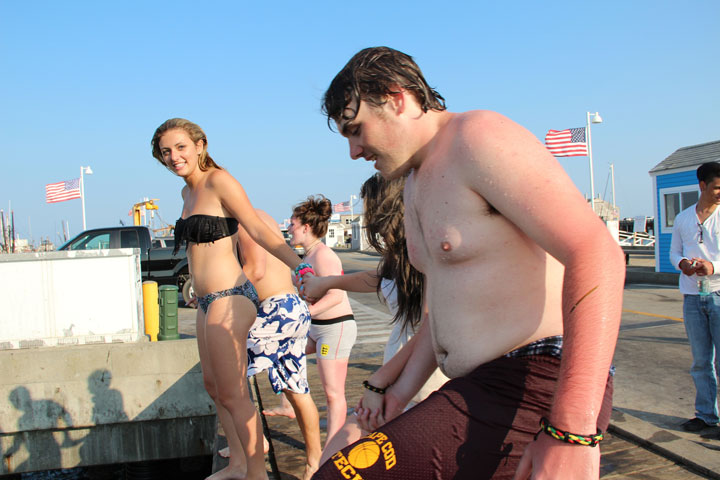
xmin=58 ymin=226 xmax=192 ymax=302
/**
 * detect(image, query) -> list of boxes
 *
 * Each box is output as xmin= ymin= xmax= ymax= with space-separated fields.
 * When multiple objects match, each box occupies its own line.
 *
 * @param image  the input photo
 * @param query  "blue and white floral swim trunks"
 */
xmin=247 ymin=294 xmax=310 ymax=394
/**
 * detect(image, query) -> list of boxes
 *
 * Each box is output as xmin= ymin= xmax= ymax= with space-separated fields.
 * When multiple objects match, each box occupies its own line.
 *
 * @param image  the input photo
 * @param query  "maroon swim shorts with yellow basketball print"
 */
xmin=313 ymin=355 xmax=613 ymax=480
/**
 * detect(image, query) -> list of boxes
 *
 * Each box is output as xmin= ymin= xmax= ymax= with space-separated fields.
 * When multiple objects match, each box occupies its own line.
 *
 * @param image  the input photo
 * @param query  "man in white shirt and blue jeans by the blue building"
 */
xmin=670 ymin=162 xmax=720 ymax=432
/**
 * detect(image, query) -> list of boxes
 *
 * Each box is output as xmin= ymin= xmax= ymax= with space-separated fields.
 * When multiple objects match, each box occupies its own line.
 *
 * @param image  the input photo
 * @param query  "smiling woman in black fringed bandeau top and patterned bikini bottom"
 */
xmin=151 ymin=118 xmax=311 ymax=479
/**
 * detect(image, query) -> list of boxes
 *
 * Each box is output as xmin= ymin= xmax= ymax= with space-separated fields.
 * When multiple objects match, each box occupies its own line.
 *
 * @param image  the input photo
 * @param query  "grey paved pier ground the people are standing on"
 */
xmin=205 ymin=252 xmax=720 ymax=480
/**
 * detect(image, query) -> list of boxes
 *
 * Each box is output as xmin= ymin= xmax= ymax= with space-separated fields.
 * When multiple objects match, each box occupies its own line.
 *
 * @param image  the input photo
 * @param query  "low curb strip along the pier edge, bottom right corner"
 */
xmin=610 ymin=409 xmax=720 ymax=479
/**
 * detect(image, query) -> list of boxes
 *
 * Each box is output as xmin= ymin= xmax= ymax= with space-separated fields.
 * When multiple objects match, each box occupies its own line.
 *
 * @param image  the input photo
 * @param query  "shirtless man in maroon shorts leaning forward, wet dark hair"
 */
xmin=313 ymin=47 xmax=624 ymax=479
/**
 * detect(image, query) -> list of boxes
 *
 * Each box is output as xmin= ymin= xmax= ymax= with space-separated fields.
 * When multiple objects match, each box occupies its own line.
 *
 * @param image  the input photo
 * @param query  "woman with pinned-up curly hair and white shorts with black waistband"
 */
xmin=288 ymin=195 xmax=357 ymax=441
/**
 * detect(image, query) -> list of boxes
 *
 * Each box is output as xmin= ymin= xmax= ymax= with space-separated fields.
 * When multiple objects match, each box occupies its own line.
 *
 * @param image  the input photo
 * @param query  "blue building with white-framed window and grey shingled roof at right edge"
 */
xmin=649 ymin=140 xmax=720 ymax=273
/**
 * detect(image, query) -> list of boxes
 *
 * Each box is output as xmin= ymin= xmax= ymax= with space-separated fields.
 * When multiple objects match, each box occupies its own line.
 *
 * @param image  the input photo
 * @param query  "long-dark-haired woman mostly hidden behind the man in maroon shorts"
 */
xmin=303 ymin=174 xmax=448 ymax=464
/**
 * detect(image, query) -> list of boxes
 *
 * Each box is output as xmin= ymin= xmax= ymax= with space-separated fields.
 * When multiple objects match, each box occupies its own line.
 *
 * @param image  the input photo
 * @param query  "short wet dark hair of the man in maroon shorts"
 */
xmin=322 ymin=47 xmax=445 ymax=129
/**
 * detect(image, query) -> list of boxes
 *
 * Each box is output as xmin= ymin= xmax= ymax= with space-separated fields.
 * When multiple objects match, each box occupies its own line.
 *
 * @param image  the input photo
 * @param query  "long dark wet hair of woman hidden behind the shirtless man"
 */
xmin=360 ymin=173 xmax=425 ymax=328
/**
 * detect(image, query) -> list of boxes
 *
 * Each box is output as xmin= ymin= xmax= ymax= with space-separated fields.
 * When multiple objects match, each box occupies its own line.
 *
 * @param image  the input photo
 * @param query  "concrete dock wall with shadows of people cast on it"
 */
xmin=0 ymin=339 xmax=215 ymax=474
